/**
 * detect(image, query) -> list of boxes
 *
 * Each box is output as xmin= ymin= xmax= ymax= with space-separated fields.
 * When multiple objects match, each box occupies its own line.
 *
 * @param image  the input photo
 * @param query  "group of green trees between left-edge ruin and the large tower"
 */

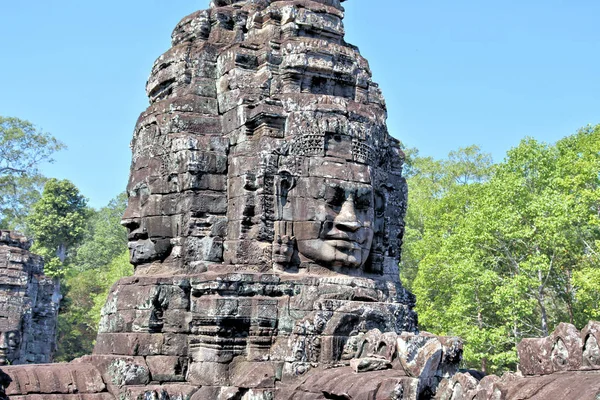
xmin=0 ymin=117 xmax=133 ymax=361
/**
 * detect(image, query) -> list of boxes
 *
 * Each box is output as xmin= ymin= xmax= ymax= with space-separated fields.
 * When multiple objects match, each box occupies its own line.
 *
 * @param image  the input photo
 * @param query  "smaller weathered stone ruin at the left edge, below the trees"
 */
xmin=0 ymin=231 xmax=58 ymax=365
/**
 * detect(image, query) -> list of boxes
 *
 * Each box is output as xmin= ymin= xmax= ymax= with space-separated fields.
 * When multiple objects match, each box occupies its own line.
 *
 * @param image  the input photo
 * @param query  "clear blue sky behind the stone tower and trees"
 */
xmin=0 ymin=0 xmax=600 ymax=207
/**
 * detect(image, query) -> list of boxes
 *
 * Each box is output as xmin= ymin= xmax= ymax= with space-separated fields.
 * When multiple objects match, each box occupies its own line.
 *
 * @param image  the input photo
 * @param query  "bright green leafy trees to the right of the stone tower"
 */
xmin=401 ymin=126 xmax=600 ymax=371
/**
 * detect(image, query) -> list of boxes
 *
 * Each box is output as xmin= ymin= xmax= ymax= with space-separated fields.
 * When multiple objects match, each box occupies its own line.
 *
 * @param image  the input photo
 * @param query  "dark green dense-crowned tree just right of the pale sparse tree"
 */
xmin=26 ymin=178 xmax=89 ymax=277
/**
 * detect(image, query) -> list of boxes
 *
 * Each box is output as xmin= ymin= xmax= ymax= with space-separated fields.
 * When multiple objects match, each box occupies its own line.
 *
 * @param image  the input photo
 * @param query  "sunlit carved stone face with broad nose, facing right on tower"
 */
xmin=290 ymin=178 xmax=374 ymax=269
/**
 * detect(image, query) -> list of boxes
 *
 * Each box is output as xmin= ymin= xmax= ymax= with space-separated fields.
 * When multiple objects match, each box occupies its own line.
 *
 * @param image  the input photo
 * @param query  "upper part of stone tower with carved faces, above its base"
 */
xmin=124 ymin=0 xmax=406 ymax=283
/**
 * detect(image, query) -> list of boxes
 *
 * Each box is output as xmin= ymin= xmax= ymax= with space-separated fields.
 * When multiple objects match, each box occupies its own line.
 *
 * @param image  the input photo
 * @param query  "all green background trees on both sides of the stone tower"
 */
xmin=0 ymin=117 xmax=600 ymax=366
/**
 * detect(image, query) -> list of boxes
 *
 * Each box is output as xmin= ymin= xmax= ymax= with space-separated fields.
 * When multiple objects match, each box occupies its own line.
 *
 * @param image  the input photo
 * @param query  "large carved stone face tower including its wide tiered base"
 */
xmin=0 ymin=0 xmax=461 ymax=400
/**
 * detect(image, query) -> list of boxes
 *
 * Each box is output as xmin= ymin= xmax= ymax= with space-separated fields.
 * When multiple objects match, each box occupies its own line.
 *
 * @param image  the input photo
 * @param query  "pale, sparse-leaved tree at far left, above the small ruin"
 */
xmin=0 ymin=116 xmax=64 ymax=229
